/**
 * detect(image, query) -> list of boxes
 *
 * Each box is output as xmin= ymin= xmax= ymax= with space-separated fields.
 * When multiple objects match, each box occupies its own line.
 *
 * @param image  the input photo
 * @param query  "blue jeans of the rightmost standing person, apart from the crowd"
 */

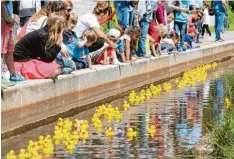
xmin=215 ymin=11 xmax=225 ymax=41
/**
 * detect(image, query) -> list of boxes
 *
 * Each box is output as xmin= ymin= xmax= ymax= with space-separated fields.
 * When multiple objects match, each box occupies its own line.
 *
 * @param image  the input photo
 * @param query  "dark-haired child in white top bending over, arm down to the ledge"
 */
xmin=121 ymin=26 xmax=141 ymax=63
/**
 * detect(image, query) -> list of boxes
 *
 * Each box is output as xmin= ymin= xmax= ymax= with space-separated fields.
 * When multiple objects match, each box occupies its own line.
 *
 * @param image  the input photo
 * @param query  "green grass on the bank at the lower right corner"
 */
xmin=211 ymin=72 xmax=234 ymax=159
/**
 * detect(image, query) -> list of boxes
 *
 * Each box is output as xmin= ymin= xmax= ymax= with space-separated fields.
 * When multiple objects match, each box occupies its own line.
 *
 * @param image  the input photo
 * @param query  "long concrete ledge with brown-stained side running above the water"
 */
xmin=1 ymin=40 xmax=234 ymax=133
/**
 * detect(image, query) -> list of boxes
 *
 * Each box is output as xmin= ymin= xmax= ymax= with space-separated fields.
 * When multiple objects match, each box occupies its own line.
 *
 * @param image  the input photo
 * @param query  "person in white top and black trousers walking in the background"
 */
xmin=202 ymin=4 xmax=211 ymax=38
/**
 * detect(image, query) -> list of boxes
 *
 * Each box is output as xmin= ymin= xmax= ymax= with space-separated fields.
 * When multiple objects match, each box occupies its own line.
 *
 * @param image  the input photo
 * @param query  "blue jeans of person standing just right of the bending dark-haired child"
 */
xmin=138 ymin=21 xmax=149 ymax=56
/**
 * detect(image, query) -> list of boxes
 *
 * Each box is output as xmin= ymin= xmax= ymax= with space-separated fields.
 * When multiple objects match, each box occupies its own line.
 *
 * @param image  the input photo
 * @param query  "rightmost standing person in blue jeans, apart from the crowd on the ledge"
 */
xmin=211 ymin=0 xmax=227 ymax=42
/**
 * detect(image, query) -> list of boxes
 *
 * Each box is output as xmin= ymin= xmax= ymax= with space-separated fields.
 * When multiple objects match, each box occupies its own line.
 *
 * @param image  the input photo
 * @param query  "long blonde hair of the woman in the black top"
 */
xmin=46 ymin=12 xmax=66 ymax=48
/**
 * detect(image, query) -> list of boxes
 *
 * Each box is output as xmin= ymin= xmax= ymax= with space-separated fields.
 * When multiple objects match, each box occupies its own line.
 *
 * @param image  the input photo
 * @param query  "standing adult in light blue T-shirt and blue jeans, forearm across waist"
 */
xmin=168 ymin=0 xmax=190 ymax=46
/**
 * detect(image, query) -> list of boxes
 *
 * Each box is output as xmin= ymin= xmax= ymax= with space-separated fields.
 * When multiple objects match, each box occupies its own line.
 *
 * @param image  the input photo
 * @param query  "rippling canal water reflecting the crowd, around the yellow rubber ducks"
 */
xmin=2 ymin=60 xmax=234 ymax=159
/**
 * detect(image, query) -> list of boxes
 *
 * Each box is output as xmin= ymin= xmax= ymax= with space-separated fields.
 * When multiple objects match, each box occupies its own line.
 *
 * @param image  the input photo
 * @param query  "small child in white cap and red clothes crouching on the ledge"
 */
xmin=93 ymin=29 xmax=122 ymax=65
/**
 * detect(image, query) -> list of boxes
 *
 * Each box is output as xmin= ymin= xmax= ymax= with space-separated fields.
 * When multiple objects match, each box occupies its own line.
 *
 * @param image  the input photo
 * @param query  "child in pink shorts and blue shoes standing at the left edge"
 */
xmin=1 ymin=1 xmax=25 ymax=82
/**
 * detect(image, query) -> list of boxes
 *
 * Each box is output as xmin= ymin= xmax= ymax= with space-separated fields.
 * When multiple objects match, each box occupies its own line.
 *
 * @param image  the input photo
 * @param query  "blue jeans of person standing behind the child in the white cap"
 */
xmin=114 ymin=1 xmax=130 ymax=28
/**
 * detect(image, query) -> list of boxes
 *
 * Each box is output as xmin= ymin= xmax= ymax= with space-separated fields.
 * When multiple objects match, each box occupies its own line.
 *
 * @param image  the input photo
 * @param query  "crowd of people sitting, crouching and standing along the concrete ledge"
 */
xmin=1 ymin=0 xmax=227 ymax=82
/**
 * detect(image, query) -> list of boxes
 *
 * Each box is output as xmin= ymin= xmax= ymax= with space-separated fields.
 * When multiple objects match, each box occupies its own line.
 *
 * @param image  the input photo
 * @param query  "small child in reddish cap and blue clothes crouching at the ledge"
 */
xmin=184 ymin=28 xmax=197 ymax=49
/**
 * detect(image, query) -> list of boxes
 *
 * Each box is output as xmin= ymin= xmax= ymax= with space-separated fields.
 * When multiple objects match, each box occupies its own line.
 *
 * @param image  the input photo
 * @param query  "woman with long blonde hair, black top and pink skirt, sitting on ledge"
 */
xmin=14 ymin=13 xmax=67 ymax=79
